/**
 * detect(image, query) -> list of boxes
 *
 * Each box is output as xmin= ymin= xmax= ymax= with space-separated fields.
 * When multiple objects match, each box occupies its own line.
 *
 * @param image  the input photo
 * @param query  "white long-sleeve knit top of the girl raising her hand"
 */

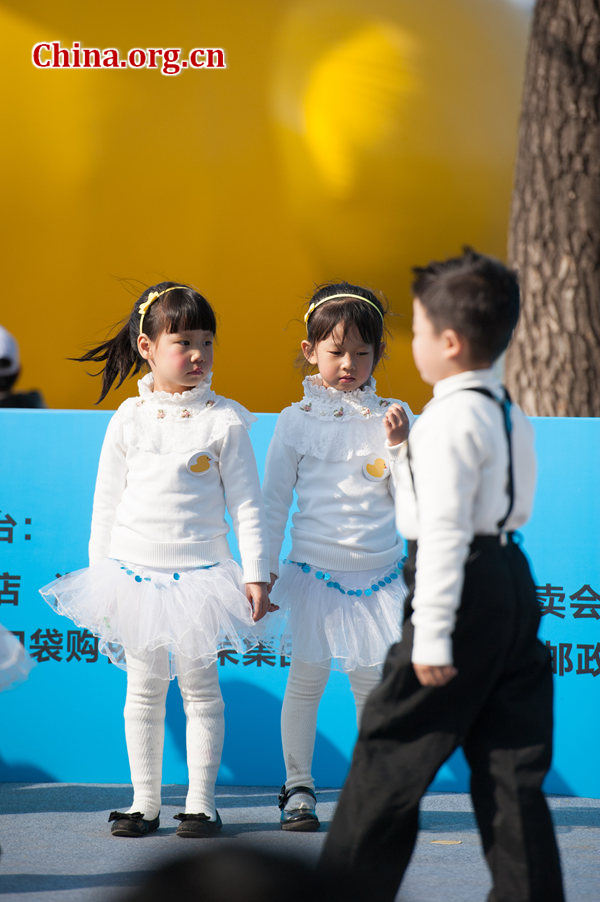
xmin=263 ymin=376 xmax=412 ymax=573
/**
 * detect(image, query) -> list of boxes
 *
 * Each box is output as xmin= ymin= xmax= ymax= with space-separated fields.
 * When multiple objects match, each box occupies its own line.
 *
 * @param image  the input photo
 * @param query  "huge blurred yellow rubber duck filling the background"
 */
xmin=0 ymin=0 xmax=527 ymax=410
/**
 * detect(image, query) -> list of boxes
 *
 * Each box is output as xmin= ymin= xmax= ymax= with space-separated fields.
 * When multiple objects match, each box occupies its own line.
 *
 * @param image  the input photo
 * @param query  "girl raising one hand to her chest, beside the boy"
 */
xmin=263 ymin=282 xmax=412 ymax=831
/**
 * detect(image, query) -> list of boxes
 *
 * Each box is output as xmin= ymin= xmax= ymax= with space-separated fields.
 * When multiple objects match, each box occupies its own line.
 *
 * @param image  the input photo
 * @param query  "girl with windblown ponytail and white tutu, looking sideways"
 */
xmin=40 ymin=282 xmax=269 ymax=837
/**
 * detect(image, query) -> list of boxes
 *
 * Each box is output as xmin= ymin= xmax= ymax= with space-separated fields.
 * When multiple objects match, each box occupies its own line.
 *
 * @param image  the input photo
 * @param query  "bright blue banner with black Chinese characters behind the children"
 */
xmin=0 ymin=410 xmax=600 ymax=798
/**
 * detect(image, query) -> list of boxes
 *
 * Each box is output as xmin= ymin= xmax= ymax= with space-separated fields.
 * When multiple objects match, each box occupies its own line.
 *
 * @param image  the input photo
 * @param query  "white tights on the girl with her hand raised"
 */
xmin=281 ymin=657 xmax=381 ymax=789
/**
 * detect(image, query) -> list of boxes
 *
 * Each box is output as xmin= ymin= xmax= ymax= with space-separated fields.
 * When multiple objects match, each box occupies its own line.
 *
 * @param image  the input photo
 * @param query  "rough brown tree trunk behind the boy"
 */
xmin=506 ymin=0 xmax=600 ymax=416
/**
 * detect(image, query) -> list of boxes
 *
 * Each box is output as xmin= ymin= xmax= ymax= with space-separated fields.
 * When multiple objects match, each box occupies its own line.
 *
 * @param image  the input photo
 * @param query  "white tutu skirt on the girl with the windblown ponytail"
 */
xmin=40 ymin=558 xmax=268 ymax=679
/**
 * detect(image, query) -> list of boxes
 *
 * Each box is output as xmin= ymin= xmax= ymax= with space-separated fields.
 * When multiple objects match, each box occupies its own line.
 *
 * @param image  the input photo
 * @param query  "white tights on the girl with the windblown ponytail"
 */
xmin=124 ymin=649 xmax=225 ymax=820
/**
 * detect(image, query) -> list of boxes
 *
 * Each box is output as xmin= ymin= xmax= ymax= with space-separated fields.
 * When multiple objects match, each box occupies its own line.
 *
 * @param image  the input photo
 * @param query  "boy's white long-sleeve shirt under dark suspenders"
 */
xmin=388 ymin=369 xmax=536 ymax=665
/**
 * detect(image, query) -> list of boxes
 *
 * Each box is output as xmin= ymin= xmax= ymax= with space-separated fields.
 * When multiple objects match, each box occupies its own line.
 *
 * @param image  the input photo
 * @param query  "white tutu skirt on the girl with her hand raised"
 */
xmin=271 ymin=561 xmax=407 ymax=671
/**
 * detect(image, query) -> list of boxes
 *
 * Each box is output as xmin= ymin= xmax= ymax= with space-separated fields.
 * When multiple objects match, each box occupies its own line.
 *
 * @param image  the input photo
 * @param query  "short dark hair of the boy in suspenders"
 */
xmin=412 ymin=247 xmax=519 ymax=364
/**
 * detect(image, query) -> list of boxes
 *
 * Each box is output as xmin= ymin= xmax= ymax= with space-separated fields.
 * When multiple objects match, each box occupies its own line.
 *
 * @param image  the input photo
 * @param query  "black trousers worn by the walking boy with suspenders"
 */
xmin=321 ymin=536 xmax=564 ymax=902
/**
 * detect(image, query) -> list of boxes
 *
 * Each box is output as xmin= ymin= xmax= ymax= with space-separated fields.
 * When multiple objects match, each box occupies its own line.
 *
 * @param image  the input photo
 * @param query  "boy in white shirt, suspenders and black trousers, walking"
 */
xmin=323 ymin=249 xmax=564 ymax=902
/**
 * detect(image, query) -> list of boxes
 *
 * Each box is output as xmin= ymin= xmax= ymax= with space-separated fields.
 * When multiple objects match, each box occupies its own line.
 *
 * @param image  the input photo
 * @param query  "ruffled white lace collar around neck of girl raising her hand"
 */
xmin=293 ymin=373 xmax=392 ymax=420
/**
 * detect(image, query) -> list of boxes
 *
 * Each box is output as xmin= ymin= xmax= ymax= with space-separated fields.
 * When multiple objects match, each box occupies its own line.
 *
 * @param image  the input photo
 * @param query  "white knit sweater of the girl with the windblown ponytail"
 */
xmin=89 ymin=374 xmax=269 ymax=582
